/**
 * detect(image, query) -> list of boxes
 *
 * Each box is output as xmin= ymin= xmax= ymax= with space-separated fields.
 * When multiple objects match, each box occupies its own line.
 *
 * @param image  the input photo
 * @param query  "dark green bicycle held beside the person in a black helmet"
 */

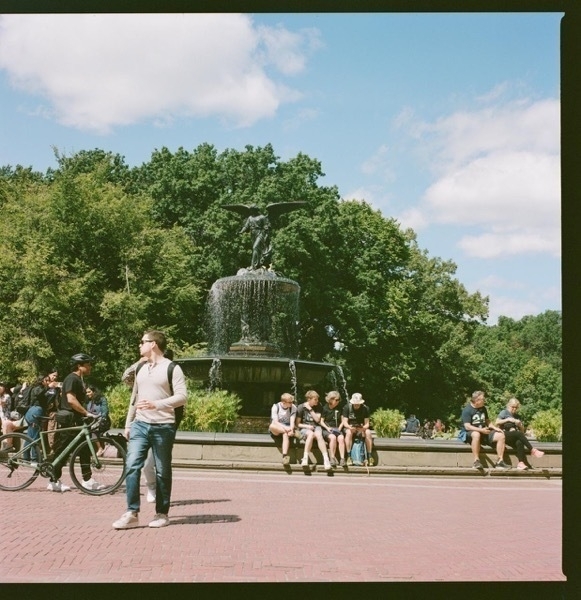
xmin=0 ymin=417 xmax=126 ymax=496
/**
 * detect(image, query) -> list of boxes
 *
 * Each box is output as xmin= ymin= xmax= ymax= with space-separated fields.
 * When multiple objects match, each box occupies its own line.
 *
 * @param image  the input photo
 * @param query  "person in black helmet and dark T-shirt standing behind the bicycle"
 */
xmin=46 ymin=352 xmax=100 ymax=492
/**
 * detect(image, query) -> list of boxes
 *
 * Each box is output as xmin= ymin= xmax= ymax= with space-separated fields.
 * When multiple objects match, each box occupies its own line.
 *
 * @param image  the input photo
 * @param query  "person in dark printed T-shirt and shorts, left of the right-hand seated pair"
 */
xmin=458 ymin=391 xmax=510 ymax=470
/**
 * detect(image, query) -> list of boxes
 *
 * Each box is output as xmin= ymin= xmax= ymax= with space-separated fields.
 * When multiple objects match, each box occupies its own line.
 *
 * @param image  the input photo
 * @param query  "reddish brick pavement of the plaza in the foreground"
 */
xmin=0 ymin=469 xmax=565 ymax=583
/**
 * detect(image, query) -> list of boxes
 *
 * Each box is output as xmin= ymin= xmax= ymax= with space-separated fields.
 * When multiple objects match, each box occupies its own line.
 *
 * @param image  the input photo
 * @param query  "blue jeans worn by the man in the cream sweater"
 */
xmin=125 ymin=421 xmax=175 ymax=515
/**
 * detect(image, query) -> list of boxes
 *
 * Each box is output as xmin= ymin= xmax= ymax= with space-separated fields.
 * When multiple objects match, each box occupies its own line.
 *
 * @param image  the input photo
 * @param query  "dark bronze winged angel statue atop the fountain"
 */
xmin=222 ymin=202 xmax=307 ymax=271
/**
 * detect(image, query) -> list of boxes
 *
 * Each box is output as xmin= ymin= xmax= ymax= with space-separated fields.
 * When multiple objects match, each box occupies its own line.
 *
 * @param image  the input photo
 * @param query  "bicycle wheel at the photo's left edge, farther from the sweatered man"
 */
xmin=0 ymin=433 xmax=42 ymax=492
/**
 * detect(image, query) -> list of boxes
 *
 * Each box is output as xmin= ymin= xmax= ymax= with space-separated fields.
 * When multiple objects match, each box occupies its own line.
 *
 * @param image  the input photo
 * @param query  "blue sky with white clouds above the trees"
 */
xmin=0 ymin=12 xmax=562 ymax=325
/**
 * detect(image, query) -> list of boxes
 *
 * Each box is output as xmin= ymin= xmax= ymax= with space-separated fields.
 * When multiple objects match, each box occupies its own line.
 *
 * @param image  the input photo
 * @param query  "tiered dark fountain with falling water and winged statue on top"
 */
xmin=176 ymin=202 xmax=347 ymax=416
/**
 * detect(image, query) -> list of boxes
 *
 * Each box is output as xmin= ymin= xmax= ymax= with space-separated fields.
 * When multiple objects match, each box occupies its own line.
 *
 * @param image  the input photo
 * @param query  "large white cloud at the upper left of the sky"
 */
xmin=0 ymin=14 xmax=317 ymax=133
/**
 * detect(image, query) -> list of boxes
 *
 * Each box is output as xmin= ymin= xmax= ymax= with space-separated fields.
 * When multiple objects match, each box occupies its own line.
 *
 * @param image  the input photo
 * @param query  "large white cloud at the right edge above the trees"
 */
xmin=397 ymin=92 xmax=561 ymax=258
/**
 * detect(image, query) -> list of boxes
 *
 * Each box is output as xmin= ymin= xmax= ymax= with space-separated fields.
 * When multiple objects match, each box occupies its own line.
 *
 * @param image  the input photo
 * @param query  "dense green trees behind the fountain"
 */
xmin=0 ymin=144 xmax=561 ymax=420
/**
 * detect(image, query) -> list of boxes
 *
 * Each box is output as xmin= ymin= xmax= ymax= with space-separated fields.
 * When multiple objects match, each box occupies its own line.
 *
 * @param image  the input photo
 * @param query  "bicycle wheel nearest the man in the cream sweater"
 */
xmin=69 ymin=438 xmax=126 ymax=496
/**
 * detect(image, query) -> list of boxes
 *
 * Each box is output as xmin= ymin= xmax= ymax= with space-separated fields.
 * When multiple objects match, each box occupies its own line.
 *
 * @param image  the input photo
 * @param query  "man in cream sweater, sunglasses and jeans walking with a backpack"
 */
xmin=113 ymin=330 xmax=187 ymax=529
